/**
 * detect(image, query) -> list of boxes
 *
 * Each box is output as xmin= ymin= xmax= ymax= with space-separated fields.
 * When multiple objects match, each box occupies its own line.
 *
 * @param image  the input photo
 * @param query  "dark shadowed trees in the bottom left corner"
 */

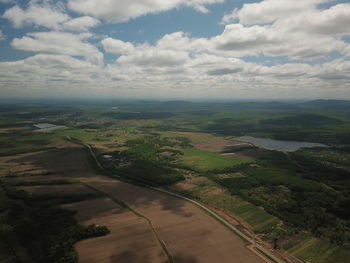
xmin=0 ymin=184 xmax=109 ymax=263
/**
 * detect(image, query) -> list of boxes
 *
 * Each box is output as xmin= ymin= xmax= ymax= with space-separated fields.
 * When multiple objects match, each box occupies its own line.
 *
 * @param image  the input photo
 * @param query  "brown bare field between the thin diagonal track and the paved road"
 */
xmin=79 ymin=177 xmax=263 ymax=263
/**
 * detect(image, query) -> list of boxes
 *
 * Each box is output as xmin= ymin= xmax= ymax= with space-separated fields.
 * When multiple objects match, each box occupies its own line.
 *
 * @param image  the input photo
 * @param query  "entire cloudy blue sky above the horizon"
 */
xmin=0 ymin=0 xmax=350 ymax=99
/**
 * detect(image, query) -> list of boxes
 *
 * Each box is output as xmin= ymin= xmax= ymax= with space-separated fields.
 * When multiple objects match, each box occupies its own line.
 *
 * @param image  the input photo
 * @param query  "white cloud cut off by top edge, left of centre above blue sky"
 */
xmin=68 ymin=0 xmax=224 ymax=22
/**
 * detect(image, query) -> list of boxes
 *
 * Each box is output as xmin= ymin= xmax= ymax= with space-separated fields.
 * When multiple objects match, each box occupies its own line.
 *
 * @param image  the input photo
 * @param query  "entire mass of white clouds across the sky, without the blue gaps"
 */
xmin=0 ymin=0 xmax=350 ymax=97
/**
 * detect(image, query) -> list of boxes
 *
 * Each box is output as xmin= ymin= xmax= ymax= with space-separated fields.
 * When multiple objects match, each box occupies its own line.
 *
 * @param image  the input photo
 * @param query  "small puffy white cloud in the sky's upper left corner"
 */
xmin=3 ymin=4 xmax=70 ymax=29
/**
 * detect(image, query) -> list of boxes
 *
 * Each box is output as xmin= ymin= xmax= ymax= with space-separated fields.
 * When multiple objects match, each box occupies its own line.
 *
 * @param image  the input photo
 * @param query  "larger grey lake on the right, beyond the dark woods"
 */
xmin=235 ymin=136 xmax=328 ymax=152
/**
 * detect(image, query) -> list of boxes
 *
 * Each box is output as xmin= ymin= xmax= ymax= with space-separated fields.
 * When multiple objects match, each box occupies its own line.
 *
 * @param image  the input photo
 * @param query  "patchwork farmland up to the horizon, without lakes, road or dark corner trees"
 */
xmin=0 ymin=101 xmax=350 ymax=263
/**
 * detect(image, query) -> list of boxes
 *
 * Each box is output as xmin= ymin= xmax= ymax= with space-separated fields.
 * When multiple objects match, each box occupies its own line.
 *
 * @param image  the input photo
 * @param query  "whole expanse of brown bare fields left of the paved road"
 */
xmin=0 ymin=147 xmax=263 ymax=263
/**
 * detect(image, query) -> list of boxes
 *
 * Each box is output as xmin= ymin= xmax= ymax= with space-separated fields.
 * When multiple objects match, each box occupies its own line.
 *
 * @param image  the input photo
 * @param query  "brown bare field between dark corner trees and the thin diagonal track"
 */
xmin=63 ymin=198 xmax=167 ymax=263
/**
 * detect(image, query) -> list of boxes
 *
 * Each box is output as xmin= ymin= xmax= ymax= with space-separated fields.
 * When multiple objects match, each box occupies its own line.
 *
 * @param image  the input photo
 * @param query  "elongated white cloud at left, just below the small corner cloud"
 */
xmin=11 ymin=32 xmax=103 ymax=64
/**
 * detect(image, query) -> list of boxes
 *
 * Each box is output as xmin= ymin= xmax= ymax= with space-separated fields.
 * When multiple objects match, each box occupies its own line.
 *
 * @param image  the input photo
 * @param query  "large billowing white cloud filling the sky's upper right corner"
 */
xmin=219 ymin=0 xmax=350 ymax=60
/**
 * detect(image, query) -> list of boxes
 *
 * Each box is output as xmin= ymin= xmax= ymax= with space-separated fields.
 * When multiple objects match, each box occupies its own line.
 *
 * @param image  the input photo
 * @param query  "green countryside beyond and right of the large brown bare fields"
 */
xmin=0 ymin=100 xmax=350 ymax=263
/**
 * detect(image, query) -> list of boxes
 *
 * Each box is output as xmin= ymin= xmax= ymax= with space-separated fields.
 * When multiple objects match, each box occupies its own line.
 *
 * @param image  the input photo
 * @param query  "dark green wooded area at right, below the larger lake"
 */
xmin=212 ymin=152 xmax=350 ymax=249
